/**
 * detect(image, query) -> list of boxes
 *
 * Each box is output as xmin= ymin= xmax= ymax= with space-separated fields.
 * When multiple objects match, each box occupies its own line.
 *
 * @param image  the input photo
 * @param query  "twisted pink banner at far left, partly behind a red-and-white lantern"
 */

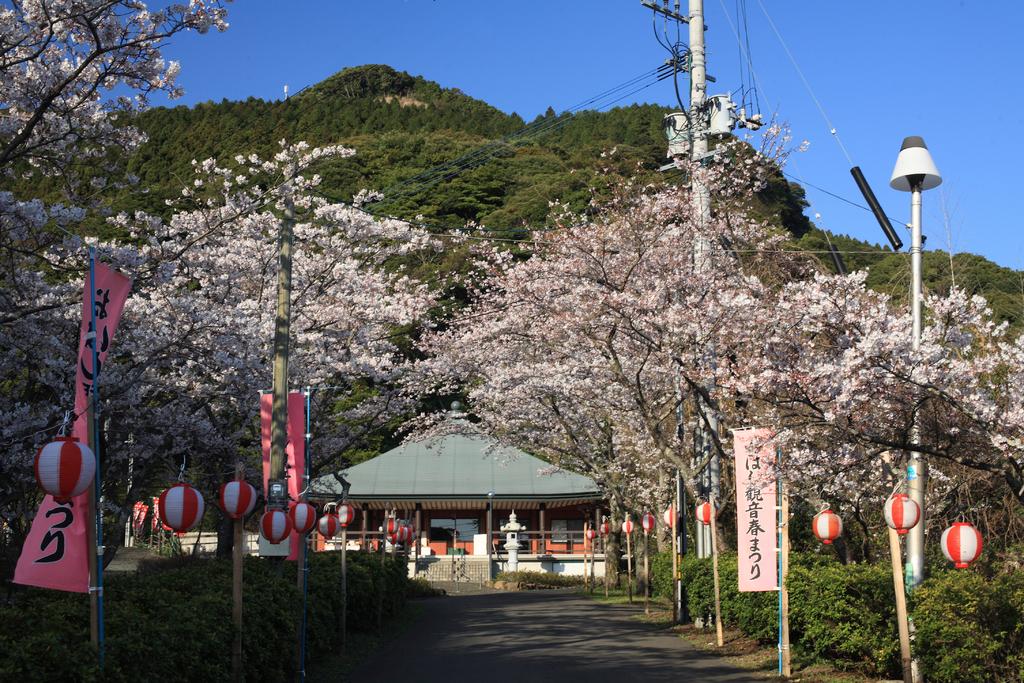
xmin=14 ymin=261 xmax=131 ymax=593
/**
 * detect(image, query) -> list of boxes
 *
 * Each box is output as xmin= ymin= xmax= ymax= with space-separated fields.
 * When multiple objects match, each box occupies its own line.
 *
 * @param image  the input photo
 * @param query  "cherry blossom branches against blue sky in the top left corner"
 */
xmin=0 ymin=0 xmax=227 ymax=179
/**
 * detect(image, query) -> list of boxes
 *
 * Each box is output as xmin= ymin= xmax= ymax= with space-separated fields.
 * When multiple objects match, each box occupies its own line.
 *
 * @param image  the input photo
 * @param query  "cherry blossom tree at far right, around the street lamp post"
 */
xmin=741 ymin=273 xmax=1024 ymax=544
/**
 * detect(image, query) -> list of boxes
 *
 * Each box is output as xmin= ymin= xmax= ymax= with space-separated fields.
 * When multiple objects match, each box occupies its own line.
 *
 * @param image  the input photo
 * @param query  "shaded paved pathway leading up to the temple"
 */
xmin=351 ymin=591 xmax=764 ymax=683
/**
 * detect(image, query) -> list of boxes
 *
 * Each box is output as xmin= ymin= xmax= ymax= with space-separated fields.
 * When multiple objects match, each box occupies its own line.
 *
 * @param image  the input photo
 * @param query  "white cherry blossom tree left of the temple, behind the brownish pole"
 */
xmin=0 ymin=143 xmax=438 ymax=557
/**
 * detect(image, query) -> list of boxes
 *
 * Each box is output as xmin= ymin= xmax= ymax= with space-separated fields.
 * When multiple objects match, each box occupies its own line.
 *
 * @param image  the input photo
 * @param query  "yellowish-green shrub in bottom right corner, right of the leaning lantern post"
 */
xmin=911 ymin=569 xmax=1024 ymax=683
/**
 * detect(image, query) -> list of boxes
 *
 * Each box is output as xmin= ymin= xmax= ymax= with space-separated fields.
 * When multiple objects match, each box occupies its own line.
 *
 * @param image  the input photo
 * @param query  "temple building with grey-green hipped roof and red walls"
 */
xmin=310 ymin=423 xmax=604 ymax=581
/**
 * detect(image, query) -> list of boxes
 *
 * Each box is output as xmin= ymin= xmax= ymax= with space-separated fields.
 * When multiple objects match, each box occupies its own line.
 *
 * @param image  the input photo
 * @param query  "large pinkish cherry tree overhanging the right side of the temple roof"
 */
xmin=418 ymin=143 xmax=793 ymax=528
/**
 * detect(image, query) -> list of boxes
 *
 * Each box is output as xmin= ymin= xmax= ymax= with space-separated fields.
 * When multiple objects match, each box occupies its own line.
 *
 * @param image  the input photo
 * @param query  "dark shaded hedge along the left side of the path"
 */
xmin=0 ymin=553 xmax=408 ymax=681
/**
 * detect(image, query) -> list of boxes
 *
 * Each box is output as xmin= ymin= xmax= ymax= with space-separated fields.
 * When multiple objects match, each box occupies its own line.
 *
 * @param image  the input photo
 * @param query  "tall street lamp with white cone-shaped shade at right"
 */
xmin=889 ymin=135 xmax=942 ymax=588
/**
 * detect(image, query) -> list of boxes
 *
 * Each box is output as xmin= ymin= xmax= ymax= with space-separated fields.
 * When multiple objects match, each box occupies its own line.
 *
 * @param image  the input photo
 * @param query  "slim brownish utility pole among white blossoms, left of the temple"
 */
xmin=267 ymin=192 xmax=295 ymax=508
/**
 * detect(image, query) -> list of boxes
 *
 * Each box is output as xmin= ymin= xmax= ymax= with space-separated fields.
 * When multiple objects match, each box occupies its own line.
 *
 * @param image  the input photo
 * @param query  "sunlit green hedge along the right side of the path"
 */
xmin=652 ymin=553 xmax=1024 ymax=683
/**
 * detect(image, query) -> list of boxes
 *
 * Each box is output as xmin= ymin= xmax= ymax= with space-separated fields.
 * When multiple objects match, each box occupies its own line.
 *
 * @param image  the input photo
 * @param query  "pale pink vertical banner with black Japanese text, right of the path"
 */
xmin=733 ymin=428 xmax=778 ymax=593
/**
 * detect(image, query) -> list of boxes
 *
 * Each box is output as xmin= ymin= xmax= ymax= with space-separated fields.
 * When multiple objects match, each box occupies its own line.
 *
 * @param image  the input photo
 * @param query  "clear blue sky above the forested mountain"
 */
xmin=158 ymin=0 xmax=1024 ymax=268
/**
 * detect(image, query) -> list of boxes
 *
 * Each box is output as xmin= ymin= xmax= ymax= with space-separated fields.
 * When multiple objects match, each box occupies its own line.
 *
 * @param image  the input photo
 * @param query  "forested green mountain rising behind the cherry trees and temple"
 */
xmin=9 ymin=65 xmax=1024 ymax=326
